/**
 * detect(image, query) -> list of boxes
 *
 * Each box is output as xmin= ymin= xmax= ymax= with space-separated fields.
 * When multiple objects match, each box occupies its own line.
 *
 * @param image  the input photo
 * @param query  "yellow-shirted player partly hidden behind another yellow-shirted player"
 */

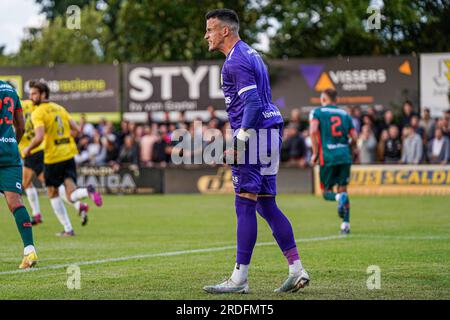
xmin=19 ymin=100 xmax=44 ymax=225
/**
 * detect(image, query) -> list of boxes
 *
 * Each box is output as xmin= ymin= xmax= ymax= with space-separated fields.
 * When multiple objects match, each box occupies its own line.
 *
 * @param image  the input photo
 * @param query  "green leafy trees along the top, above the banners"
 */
xmin=0 ymin=0 xmax=450 ymax=66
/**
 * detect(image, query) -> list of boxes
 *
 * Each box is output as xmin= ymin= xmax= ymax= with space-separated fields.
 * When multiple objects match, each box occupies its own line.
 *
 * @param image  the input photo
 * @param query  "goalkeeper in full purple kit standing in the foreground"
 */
xmin=204 ymin=9 xmax=309 ymax=293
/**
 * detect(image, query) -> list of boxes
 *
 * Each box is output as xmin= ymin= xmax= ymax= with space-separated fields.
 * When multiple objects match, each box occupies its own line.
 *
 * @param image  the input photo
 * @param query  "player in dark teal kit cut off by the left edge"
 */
xmin=0 ymin=80 xmax=38 ymax=269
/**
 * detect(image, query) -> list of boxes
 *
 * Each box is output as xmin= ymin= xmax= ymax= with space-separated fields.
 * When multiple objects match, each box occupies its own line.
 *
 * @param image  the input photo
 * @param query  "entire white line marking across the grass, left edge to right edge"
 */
xmin=0 ymin=234 xmax=450 ymax=275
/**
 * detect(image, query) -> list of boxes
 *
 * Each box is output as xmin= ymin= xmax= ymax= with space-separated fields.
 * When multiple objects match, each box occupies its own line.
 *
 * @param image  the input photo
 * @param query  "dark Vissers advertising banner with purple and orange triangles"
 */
xmin=269 ymin=56 xmax=419 ymax=116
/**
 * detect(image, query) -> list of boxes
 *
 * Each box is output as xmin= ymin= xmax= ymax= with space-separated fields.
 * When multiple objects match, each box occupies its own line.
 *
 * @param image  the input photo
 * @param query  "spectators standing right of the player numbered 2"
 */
xmin=348 ymin=101 xmax=450 ymax=164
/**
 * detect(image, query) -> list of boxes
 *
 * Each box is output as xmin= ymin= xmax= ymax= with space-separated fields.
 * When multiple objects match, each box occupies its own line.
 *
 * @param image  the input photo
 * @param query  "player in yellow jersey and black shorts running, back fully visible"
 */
xmin=23 ymin=82 xmax=102 ymax=236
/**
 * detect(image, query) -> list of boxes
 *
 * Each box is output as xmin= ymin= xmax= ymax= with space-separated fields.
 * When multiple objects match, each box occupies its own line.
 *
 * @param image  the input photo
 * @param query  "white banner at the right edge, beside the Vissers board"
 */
xmin=420 ymin=53 xmax=450 ymax=117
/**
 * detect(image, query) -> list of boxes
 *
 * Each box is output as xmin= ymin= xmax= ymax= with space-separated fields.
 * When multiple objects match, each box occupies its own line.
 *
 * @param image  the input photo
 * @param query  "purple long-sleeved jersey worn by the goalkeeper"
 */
xmin=222 ymin=40 xmax=283 ymax=130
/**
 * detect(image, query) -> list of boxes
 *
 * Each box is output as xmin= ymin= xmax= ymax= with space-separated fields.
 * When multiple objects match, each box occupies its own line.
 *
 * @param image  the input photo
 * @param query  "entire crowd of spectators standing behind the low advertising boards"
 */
xmin=76 ymin=101 xmax=450 ymax=167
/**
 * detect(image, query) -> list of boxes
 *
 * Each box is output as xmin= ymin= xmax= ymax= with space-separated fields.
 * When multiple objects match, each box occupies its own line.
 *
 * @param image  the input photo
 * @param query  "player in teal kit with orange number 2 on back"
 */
xmin=310 ymin=89 xmax=358 ymax=234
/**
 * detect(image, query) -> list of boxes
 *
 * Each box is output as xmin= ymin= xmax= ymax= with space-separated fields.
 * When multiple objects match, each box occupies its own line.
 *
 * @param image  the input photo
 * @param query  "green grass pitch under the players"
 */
xmin=0 ymin=195 xmax=450 ymax=299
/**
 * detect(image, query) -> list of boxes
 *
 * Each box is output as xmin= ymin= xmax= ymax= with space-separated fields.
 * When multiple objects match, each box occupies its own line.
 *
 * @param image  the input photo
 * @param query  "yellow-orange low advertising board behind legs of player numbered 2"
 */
xmin=314 ymin=165 xmax=450 ymax=195
